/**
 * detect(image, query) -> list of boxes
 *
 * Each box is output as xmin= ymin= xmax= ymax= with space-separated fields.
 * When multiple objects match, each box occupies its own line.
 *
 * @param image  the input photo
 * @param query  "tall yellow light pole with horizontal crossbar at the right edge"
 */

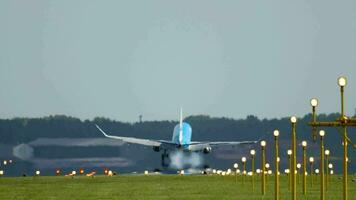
xmin=308 ymin=76 xmax=356 ymax=200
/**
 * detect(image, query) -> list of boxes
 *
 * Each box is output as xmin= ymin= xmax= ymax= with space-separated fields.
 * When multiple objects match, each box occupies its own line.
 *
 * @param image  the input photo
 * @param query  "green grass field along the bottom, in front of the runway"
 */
xmin=0 ymin=175 xmax=356 ymax=200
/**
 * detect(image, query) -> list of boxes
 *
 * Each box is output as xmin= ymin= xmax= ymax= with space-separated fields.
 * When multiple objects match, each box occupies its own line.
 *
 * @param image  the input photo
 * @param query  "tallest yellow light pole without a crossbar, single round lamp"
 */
xmin=290 ymin=116 xmax=297 ymax=200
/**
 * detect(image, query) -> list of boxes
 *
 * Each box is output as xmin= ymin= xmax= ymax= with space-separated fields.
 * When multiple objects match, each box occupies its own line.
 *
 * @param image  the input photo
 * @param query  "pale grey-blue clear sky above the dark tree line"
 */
xmin=0 ymin=0 xmax=356 ymax=122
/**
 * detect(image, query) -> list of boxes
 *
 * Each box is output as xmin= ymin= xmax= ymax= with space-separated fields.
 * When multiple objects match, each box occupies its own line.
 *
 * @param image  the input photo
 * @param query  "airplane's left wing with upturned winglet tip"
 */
xmin=95 ymin=124 xmax=172 ymax=147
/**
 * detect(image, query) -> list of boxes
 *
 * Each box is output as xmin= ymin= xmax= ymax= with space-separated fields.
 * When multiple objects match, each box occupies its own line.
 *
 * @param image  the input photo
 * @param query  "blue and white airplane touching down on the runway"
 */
xmin=95 ymin=109 xmax=258 ymax=167
